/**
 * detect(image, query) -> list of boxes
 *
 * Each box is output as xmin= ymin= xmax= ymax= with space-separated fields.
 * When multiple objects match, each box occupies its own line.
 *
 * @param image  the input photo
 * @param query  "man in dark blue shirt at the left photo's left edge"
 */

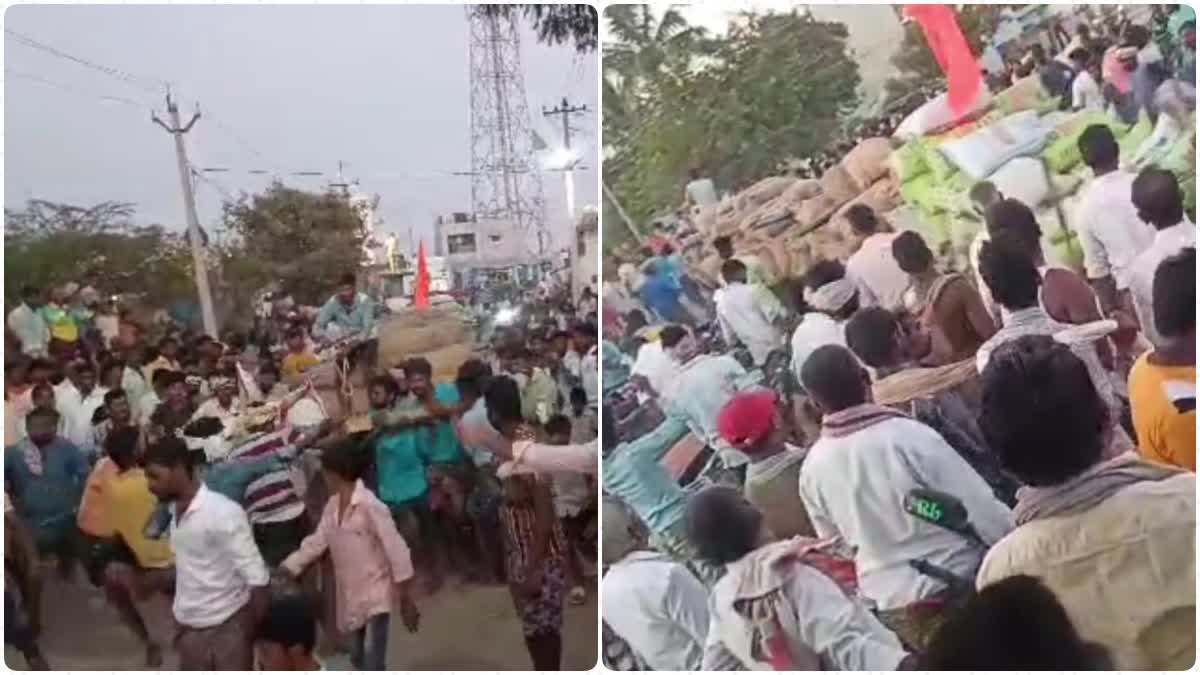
xmin=4 ymin=407 xmax=89 ymax=575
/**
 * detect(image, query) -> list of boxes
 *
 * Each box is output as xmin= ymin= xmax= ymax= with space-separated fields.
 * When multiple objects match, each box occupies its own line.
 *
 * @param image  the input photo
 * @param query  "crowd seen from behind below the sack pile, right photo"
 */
xmin=601 ymin=118 xmax=1196 ymax=670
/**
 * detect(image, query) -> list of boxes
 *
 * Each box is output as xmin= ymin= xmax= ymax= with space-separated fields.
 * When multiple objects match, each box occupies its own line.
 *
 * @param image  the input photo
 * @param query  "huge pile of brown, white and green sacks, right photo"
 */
xmin=683 ymin=76 xmax=1196 ymax=282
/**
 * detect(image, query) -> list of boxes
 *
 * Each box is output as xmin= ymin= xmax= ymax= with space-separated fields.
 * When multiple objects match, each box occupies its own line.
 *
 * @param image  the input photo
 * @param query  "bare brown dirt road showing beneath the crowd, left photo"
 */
xmin=5 ymin=574 xmax=598 ymax=670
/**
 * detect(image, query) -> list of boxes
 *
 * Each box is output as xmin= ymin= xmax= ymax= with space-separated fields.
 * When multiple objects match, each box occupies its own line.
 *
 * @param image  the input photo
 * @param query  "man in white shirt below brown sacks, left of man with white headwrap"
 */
xmin=715 ymin=259 xmax=787 ymax=366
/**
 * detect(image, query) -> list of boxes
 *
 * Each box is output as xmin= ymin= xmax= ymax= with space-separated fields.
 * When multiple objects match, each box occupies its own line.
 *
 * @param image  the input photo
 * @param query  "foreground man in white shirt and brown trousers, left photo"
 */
xmin=145 ymin=436 xmax=270 ymax=670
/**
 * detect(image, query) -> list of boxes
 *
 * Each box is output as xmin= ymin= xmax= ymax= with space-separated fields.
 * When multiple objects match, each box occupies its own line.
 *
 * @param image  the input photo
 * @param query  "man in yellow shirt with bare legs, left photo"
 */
xmin=93 ymin=426 xmax=174 ymax=668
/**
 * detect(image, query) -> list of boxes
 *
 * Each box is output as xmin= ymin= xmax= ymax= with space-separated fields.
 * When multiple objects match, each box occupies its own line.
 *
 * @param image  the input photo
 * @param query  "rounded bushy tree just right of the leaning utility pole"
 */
xmin=222 ymin=183 xmax=366 ymax=304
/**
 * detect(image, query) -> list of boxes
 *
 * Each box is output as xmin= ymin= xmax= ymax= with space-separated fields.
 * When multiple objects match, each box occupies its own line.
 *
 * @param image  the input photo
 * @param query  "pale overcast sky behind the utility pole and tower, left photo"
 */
xmin=4 ymin=5 xmax=598 ymax=251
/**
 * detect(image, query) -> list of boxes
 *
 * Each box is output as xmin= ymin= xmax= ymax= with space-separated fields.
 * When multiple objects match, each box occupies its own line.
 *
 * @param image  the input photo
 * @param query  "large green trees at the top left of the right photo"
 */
xmin=604 ymin=5 xmax=859 ymax=235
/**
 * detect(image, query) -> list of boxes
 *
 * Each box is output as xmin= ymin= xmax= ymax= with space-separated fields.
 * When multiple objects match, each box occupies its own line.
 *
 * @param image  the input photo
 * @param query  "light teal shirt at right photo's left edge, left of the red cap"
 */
xmin=601 ymin=417 xmax=688 ymax=533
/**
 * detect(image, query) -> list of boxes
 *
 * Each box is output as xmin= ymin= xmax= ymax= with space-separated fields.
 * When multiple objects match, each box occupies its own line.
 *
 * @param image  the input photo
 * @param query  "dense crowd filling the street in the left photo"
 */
xmin=5 ymin=267 xmax=599 ymax=670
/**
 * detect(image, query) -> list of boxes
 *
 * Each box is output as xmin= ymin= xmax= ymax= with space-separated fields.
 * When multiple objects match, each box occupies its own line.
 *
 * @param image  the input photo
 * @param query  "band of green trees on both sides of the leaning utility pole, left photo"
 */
xmin=5 ymin=184 xmax=365 ymax=329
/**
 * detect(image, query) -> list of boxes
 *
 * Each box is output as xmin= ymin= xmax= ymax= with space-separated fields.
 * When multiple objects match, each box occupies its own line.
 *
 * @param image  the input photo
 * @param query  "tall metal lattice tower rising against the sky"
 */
xmin=467 ymin=5 xmax=548 ymax=258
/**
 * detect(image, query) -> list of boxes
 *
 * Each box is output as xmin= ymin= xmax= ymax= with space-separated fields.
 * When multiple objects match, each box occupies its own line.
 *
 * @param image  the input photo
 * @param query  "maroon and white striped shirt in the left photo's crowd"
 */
xmin=223 ymin=426 xmax=305 ymax=525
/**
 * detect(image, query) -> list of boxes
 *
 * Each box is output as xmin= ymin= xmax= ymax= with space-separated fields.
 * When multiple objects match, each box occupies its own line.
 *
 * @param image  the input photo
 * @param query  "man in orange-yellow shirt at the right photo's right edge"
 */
xmin=1129 ymin=249 xmax=1196 ymax=471
